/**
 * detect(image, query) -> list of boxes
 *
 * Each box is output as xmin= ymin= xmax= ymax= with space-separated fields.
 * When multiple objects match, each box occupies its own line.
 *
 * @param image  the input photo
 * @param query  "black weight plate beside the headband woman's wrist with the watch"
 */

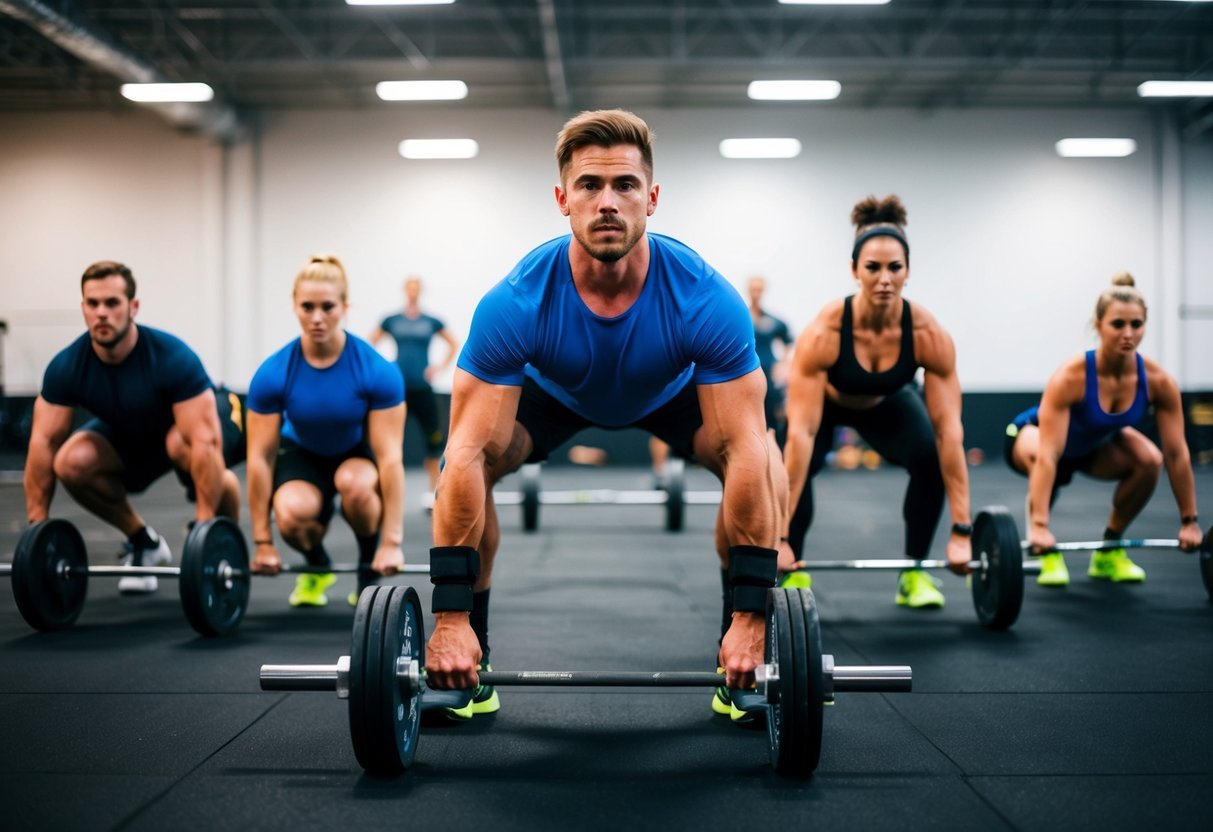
xmin=972 ymin=506 xmax=1024 ymax=629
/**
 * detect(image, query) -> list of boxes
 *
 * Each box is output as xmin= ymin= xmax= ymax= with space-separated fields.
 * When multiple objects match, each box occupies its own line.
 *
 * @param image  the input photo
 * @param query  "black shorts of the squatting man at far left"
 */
xmin=79 ymin=387 xmax=247 ymax=502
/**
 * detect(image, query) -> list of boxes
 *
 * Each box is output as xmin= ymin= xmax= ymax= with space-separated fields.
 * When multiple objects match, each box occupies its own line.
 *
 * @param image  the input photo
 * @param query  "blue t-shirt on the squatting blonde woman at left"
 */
xmin=249 ymin=332 xmax=404 ymax=456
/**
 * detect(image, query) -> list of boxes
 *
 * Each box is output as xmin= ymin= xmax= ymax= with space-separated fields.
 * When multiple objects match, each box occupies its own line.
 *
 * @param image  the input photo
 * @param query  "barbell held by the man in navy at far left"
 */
xmin=0 ymin=517 xmax=429 ymax=636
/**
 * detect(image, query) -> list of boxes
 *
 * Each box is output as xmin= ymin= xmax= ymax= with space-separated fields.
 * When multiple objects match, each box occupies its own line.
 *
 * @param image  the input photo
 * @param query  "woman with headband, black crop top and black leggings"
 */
xmin=784 ymin=195 xmax=973 ymax=609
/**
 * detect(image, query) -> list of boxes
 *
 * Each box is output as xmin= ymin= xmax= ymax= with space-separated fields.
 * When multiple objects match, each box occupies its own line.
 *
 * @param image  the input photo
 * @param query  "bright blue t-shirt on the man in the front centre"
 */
xmin=459 ymin=234 xmax=758 ymax=427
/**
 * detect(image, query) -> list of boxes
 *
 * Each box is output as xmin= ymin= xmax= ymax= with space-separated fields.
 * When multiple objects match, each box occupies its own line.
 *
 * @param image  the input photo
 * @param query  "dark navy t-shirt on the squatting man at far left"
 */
xmin=42 ymin=325 xmax=211 ymax=441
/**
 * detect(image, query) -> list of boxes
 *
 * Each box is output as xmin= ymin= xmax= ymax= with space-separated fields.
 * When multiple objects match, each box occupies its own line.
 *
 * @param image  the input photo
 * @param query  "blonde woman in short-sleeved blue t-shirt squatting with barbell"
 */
xmin=247 ymin=255 xmax=404 ymax=606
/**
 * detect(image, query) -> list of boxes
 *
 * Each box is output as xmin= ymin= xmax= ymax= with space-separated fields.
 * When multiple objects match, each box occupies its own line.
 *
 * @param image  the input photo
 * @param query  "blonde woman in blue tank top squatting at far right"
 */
xmin=1004 ymin=272 xmax=1201 ymax=586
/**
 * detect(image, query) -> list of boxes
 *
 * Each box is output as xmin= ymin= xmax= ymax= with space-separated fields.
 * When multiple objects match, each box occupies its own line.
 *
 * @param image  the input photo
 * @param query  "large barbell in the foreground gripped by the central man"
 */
xmin=260 ymin=586 xmax=912 ymax=776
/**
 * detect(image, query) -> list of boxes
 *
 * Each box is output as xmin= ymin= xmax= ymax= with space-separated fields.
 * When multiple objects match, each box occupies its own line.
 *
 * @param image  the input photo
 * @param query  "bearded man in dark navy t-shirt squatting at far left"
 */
xmin=25 ymin=261 xmax=241 ymax=593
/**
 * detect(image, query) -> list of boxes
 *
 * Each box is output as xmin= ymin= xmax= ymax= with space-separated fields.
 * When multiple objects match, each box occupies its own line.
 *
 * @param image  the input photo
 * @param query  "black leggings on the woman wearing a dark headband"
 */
xmin=788 ymin=387 xmax=944 ymax=559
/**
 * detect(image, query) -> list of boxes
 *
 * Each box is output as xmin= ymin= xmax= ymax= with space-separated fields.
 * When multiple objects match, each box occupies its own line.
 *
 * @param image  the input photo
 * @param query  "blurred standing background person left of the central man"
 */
xmin=368 ymin=275 xmax=459 ymax=491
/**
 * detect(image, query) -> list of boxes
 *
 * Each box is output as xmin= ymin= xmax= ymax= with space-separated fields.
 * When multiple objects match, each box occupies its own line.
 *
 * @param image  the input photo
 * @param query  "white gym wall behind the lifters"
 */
xmin=0 ymin=106 xmax=1213 ymax=395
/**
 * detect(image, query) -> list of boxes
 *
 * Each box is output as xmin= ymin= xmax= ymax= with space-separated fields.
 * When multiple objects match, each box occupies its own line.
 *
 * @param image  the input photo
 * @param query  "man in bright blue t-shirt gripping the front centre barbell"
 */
xmin=426 ymin=110 xmax=786 ymax=719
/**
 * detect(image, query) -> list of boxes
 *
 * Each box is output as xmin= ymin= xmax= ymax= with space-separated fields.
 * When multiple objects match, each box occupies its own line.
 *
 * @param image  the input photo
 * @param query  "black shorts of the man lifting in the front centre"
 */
xmin=518 ymin=376 xmax=704 ymax=462
